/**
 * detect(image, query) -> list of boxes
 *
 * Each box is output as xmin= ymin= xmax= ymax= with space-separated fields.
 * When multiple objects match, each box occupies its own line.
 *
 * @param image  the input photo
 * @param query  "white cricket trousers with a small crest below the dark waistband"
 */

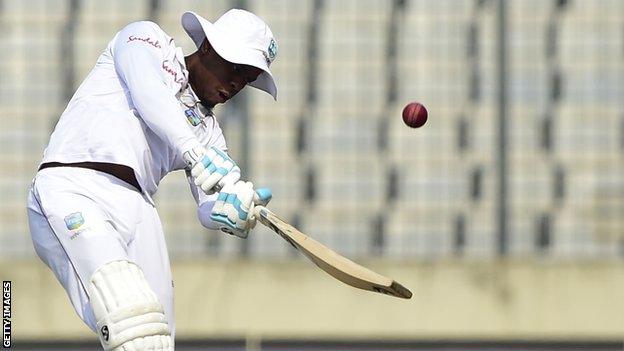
xmin=28 ymin=167 xmax=175 ymax=340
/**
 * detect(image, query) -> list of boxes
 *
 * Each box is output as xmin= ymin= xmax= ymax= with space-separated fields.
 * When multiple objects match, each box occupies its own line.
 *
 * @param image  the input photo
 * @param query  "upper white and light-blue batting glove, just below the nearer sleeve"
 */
xmin=183 ymin=146 xmax=240 ymax=195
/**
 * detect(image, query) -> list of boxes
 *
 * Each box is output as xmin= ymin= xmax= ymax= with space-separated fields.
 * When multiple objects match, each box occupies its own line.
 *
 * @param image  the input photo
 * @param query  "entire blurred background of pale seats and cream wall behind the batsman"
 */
xmin=0 ymin=0 xmax=624 ymax=350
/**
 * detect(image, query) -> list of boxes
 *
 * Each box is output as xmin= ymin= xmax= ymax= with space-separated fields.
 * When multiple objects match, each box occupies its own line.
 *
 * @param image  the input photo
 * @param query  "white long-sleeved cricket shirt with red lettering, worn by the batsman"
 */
xmin=42 ymin=21 xmax=226 ymax=202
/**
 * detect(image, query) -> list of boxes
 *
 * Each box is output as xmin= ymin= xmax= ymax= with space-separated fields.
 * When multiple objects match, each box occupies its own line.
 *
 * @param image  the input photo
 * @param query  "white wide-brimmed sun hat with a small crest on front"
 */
xmin=182 ymin=9 xmax=277 ymax=100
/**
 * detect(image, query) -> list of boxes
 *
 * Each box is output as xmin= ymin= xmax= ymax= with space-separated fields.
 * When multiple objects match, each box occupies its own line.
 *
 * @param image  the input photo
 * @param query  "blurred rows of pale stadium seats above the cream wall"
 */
xmin=0 ymin=0 xmax=624 ymax=259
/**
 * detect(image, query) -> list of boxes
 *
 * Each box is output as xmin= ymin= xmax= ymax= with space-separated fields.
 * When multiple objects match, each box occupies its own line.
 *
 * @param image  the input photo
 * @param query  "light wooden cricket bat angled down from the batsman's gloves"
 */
xmin=254 ymin=205 xmax=412 ymax=299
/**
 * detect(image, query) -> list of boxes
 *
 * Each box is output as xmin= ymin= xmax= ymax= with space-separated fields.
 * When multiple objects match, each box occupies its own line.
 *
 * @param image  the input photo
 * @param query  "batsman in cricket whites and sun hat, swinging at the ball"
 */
xmin=28 ymin=9 xmax=277 ymax=351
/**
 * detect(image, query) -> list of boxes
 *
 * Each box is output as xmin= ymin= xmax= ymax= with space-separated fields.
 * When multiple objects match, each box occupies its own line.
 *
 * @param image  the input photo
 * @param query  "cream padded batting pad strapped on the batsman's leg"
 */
xmin=88 ymin=261 xmax=173 ymax=351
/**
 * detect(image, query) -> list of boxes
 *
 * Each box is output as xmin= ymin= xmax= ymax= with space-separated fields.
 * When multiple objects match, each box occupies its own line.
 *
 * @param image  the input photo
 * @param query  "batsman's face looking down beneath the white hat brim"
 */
xmin=189 ymin=41 xmax=262 ymax=107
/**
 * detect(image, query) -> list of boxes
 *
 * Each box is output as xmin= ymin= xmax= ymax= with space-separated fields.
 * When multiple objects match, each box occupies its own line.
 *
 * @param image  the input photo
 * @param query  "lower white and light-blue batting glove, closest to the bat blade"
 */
xmin=210 ymin=181 xmax=272 ymax=239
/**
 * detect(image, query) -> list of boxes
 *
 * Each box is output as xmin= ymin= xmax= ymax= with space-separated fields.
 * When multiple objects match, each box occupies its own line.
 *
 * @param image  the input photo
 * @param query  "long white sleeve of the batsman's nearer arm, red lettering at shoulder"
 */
xmin=113 ymin=22 xmax=200 ymax=154
